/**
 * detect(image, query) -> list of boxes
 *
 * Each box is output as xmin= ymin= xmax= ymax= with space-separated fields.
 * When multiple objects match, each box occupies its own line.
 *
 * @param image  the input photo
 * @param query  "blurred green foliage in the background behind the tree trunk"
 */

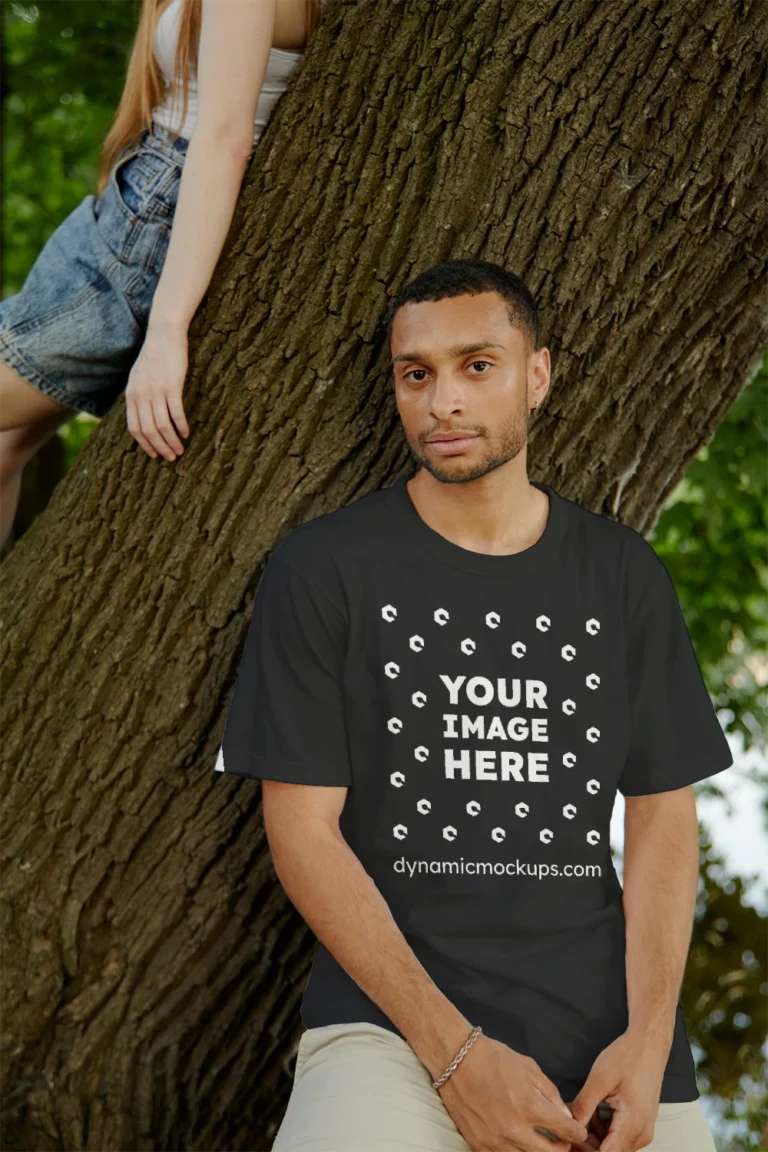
xmin=2 ymin=0 xmax=768 ymax=1152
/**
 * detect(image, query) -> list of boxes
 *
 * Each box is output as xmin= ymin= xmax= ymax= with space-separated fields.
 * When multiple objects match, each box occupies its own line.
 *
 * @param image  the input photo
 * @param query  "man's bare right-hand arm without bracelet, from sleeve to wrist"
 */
xmin=624 ymin=788 xmax=699 ymax=1059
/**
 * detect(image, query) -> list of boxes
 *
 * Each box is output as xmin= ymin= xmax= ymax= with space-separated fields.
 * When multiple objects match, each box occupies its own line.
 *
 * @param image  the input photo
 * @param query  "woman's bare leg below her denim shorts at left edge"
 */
xmin=0 ymin=362 xmax=77 ymax=547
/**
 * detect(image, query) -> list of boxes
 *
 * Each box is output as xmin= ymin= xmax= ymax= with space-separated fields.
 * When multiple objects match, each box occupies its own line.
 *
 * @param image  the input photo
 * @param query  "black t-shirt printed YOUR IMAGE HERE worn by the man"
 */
xmin=216 ymin=480 xmax=732 ymax=1102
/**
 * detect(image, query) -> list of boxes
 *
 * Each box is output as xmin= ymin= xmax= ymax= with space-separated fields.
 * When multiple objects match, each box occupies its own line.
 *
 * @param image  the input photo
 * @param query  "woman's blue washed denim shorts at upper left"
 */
xmin=0 ymin=124 xmax=188 ymax=417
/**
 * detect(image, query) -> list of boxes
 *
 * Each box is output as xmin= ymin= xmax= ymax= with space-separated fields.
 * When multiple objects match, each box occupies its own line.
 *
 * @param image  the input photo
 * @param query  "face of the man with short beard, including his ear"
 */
xmin=391 ymin=291 xmax=549 ymax=483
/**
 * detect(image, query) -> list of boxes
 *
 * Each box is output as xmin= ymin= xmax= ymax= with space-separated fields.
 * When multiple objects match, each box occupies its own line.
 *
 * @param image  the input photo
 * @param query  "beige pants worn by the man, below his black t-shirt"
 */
xmin=272 ymin=1023 xmax=715 ymax=1152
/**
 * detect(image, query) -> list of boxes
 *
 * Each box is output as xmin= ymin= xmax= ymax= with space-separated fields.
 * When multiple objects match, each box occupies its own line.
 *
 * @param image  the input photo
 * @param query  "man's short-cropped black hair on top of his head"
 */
xmin=387 ymin=259 xmax=539 ymax=351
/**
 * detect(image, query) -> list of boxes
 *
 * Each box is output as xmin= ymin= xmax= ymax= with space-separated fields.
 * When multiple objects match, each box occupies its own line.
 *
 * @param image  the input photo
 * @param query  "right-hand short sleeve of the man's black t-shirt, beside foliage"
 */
xmin=618 ymin=539 xmax=733 ymax=796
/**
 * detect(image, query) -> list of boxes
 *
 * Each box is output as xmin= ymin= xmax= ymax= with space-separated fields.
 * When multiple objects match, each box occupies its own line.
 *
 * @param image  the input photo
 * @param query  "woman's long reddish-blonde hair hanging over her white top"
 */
xmin=97 ymin=0 xmax=320 ymax=192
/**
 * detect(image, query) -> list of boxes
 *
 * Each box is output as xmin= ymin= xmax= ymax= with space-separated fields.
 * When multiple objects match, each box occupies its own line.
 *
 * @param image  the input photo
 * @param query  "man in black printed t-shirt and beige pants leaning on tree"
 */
xmin=216 ymin=260 xmax=732 ymax=1152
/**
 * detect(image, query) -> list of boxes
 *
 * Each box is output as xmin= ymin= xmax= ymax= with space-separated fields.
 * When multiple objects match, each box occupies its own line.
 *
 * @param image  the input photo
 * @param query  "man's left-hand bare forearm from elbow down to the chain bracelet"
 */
xmin=269 ymin=821 xmax=473 ymax=1079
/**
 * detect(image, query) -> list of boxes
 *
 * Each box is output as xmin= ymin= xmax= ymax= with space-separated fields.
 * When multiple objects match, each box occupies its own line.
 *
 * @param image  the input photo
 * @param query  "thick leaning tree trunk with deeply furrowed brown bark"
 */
xmin=0 ymin=0 xmax=768 ymax=1152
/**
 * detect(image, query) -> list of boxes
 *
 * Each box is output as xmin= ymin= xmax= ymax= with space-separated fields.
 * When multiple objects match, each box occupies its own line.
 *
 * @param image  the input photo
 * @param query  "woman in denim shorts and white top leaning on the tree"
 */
xmin=0 ymin=0 xmax=321 ymax=544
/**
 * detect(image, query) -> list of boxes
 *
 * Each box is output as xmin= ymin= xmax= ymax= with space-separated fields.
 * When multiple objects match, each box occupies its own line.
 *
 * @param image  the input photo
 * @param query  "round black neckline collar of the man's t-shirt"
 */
xmin=387 ymin=478 xmax=564 ymax=576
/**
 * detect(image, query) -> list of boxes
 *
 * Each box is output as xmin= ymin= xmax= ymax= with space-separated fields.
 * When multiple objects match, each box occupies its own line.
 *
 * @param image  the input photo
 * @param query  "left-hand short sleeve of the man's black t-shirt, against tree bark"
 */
xmin=215 ymin=552 xmax=352 ymax=786
